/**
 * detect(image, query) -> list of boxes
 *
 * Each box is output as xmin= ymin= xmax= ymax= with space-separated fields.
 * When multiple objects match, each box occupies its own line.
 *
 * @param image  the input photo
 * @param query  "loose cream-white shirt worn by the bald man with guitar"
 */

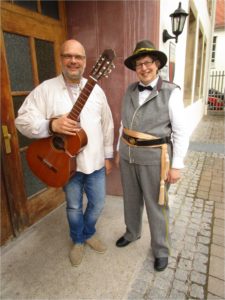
xmin=15 ymin=75 xmax=114 ymax=174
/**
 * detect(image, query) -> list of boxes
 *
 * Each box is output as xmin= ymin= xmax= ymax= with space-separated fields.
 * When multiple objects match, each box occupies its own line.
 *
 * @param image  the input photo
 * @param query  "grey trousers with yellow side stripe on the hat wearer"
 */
xmin=120 ymin=159 xmax=170 ymax=257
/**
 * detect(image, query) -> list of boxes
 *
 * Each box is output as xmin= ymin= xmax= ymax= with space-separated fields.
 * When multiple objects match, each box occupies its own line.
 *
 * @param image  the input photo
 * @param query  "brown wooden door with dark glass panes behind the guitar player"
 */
xmin=1 ymin=0 xmax=66 ymax=244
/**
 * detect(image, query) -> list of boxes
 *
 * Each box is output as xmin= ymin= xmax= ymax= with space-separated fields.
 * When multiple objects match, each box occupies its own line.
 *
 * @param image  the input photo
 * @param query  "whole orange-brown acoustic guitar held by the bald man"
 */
xmin=26 ymin=49 xmax=115 ymax=187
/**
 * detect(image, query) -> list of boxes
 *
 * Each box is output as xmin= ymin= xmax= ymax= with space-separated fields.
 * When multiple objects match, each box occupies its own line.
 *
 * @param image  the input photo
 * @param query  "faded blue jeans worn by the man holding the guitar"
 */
xmin=64 ymin=167 xmax=106 ymax=244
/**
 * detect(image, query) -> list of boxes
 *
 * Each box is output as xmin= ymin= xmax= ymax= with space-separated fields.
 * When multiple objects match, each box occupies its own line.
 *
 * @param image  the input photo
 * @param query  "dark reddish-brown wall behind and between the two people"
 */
xmin=65 ymin=0 xmax=159 ymax=195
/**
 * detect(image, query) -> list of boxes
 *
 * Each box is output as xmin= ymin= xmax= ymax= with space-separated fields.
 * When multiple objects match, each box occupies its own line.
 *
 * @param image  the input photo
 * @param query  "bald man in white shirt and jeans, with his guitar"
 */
xmin=15 ymin=39 xmax=114 ymax=266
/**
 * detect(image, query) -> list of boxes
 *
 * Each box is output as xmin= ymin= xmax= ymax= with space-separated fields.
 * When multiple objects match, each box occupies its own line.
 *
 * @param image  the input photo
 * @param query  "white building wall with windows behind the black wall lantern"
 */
xmin=160 ymin=0 xmax=216 ymax=134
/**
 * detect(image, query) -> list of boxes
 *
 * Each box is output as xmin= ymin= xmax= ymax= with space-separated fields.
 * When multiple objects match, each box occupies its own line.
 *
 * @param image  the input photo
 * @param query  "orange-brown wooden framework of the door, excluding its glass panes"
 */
xmin=0 ymin=1 xmax=67 ymax=244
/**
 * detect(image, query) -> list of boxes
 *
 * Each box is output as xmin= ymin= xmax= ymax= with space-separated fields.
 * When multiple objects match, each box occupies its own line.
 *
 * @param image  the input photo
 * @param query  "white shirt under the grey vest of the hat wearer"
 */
xmin=117 ymin=77 xmax=189 ymax=169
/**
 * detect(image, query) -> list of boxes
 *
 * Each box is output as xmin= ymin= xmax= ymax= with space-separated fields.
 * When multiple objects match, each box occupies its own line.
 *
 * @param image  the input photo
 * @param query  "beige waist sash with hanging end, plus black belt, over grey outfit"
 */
xmin=122 ymin=128 xmax=171 ymax=205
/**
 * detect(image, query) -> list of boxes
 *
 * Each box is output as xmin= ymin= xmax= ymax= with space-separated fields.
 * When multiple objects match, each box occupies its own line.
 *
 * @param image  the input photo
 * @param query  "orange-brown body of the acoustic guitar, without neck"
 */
xmin=26 ymin=129 xmax=87 ymax=187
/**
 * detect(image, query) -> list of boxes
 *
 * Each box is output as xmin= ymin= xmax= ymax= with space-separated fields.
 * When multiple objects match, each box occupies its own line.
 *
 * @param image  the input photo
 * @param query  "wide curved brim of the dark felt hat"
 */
xmin=124 ymin=50 xmax=167 ymax=71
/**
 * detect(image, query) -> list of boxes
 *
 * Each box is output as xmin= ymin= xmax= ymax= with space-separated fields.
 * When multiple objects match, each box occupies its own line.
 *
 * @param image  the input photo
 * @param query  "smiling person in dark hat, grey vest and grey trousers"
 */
xmin=116 ymin=40 xmax=188 ymax=271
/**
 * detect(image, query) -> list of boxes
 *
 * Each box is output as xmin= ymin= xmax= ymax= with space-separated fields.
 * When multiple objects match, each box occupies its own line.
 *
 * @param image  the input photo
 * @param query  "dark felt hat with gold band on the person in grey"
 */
xmin=124 ymin=40 xmax=167 ymax=71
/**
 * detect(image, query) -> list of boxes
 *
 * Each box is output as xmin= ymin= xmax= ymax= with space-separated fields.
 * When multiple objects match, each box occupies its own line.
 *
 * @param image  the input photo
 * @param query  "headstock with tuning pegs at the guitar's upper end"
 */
xmin=91 ymin=49 xmax=116 ymax=80
